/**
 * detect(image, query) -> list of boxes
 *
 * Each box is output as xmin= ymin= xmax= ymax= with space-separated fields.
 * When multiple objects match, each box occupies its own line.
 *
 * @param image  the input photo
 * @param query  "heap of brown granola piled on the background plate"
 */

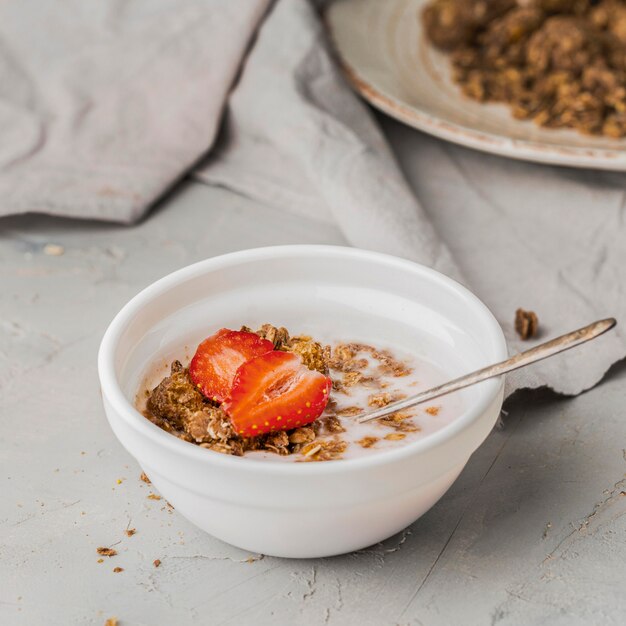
xmin=422 ymin=0 xmax=626 ymax=138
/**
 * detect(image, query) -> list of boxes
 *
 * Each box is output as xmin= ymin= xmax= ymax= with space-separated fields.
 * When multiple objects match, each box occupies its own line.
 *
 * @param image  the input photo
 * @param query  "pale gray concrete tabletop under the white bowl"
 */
xmin=0 ymin=130 xmax=626 ymax=626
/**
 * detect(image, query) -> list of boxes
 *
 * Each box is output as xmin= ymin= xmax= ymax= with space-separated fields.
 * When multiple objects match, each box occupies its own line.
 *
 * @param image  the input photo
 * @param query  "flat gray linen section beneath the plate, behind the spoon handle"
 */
xmin=385 ymin=123 xmax=626 ymax=395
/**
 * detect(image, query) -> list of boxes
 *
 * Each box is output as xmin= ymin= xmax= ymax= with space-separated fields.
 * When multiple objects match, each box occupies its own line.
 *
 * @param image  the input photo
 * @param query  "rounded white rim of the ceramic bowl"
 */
xmin=98 ymin=244 xmax=508 ymax=476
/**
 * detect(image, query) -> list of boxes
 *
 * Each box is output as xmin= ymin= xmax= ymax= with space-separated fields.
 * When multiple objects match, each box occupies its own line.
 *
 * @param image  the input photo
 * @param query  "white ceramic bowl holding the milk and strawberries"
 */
xmin=98 ymin=246 xmax=507 ymax=558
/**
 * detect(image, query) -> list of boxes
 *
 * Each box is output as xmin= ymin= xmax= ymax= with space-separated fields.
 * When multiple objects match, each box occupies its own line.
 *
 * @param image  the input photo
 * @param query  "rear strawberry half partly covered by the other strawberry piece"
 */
xmin=189 ymin=328 xmax=274 ymax=402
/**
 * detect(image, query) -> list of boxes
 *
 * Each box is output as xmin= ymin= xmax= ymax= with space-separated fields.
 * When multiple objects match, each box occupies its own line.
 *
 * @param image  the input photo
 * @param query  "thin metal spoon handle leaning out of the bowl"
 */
xmin=356 ymin=317 xmax=617 ymax=423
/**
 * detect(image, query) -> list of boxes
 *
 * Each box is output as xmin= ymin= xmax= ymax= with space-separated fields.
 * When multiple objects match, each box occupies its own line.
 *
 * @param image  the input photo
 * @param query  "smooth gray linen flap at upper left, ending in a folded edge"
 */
xmin=0 ymin=0 xmax=269 ymax=222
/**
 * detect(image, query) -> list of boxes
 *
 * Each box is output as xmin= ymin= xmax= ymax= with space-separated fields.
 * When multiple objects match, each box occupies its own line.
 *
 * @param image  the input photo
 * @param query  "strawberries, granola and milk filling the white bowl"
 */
xmin=137 ymin=324 xmax=460 ymax=462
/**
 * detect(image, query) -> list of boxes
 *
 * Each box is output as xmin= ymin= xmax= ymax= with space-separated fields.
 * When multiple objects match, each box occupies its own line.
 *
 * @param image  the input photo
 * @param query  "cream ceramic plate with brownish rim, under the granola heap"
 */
xmin=326 ymin=0 xmax=626 ymax=170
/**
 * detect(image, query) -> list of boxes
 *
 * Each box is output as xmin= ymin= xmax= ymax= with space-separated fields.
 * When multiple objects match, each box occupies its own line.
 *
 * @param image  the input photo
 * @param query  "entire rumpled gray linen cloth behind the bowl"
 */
xmin=0 ymin=0 xmax=626 ymax=394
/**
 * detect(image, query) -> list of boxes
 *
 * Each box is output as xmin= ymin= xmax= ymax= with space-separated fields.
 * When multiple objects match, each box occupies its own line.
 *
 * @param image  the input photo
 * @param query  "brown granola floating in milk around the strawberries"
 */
xmin=144 ymin=324 xmax=419 ymax=462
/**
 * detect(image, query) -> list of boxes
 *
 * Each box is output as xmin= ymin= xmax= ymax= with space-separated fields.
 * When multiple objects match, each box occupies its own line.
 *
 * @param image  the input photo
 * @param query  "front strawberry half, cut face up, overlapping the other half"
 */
xmin=222 ymin=350 xmax=330 ymax=437
